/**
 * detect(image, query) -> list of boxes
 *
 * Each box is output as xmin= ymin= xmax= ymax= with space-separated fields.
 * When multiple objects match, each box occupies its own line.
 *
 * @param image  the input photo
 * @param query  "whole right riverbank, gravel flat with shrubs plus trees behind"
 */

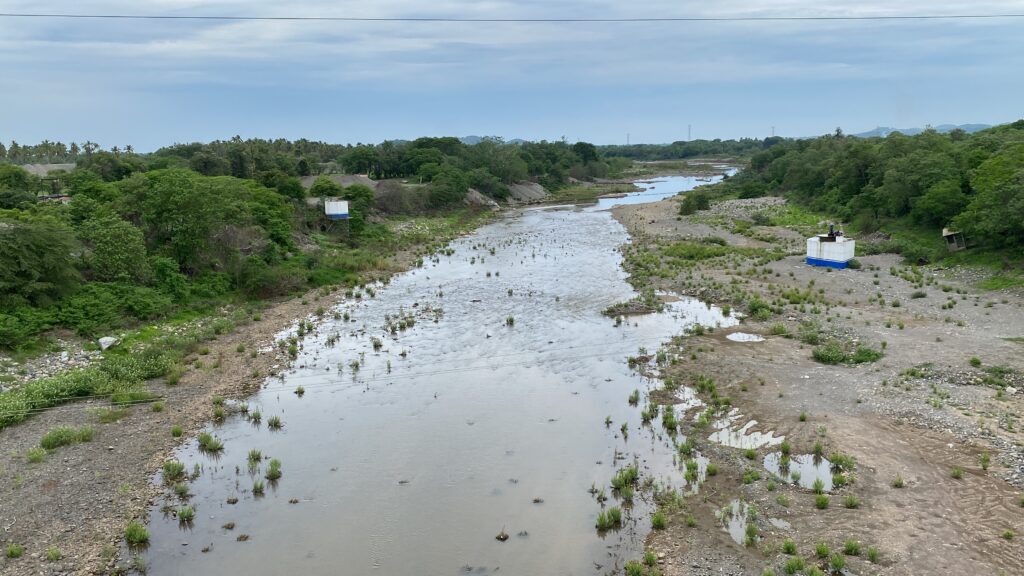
xmin=614 ymin=122 xmax=1024 ymax=575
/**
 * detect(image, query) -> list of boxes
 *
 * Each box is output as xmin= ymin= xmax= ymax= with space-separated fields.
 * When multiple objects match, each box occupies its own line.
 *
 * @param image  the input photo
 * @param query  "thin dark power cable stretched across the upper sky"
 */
xmin=0 ymin=12 xmax=1024 ymax=24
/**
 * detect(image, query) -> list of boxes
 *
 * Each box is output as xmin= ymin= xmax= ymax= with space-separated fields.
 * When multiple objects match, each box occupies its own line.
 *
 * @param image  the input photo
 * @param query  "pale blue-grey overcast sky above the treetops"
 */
xmin=0 ymin=0 xmax=1024 ymax=152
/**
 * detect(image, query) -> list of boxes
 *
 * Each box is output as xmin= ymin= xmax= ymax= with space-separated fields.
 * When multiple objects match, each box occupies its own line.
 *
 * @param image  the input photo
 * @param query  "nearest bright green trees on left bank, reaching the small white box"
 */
xmin=0 ymin=165 xmax=373 ymax=348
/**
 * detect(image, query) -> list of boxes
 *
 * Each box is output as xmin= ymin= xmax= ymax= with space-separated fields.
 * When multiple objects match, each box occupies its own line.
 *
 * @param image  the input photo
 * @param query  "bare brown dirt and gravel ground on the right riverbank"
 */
xmin=613 ymin=194 xmax=1024 ymax=575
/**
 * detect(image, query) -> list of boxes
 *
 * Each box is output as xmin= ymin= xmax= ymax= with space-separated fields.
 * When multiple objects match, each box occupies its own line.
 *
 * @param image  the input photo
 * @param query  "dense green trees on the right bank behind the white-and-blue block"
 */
xmin=722 ymin=120 xmax=1024 ymax=258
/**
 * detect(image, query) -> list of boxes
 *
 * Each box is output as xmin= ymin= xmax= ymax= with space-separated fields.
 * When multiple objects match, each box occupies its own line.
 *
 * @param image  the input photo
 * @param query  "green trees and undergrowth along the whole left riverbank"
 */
xmin=0 ymin=138 xmax=629 ymax=428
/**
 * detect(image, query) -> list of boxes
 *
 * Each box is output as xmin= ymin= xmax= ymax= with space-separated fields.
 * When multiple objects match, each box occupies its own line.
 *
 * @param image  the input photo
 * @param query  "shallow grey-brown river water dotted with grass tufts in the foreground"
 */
xmin=145 ymin=177 xmax=736 ymax=575
